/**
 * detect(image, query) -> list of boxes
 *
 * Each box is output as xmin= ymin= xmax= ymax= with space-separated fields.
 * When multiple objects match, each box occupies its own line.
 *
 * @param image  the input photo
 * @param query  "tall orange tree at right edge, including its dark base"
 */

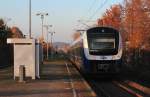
xmin=124 ymin=0 xmax=150 ymax=66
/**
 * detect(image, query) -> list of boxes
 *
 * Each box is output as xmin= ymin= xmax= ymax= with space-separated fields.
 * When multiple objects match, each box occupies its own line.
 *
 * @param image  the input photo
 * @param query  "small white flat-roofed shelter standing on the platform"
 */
xmin=7 ymin=38 xmax=41 ymax=79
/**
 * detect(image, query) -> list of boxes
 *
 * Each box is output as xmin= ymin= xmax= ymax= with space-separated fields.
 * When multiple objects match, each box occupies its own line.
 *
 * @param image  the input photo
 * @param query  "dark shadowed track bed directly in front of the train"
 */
xmin=90 ymin=81 xmax=135 ymax=97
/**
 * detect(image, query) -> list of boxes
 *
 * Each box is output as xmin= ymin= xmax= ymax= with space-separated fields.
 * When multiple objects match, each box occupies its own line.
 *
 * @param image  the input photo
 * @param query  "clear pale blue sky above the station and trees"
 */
xmin=0 ymin=0 xmax=123 ymax=42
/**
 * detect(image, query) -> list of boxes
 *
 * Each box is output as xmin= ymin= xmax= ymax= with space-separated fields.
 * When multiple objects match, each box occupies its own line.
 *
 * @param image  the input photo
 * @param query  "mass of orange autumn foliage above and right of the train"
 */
xmin=98 ymin=0 xmax=150 ymax=48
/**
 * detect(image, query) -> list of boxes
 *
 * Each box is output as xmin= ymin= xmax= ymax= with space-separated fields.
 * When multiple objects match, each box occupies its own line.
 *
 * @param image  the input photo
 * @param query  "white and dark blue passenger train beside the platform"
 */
xmin=69 ymin=27 xmax=123 ymax=74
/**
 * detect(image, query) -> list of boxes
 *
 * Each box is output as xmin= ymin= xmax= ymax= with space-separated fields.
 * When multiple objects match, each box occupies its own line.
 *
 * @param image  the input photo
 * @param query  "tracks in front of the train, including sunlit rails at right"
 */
xmin=88 ymin=80 xmax=150 ymax=97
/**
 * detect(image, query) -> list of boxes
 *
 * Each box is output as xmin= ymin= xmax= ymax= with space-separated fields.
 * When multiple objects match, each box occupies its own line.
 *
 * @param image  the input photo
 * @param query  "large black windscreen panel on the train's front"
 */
xmin=87 ymin=27 xmax=119 ymax=55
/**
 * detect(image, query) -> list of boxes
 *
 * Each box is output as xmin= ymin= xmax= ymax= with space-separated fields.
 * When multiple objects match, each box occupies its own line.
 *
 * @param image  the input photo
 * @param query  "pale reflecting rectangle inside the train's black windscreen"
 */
xmin=89 ymin=39 xmax=115 ymax=50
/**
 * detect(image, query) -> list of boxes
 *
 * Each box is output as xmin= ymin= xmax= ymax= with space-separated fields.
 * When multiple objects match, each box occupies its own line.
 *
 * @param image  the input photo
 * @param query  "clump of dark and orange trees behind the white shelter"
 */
xmin=0 ymin=19 xmax=24 ymax=67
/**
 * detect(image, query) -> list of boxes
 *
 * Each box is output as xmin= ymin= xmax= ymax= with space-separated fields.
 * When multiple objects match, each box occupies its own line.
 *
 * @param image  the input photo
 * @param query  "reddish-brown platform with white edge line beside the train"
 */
xmin=0 ymin=60 xmax=96 ymax=97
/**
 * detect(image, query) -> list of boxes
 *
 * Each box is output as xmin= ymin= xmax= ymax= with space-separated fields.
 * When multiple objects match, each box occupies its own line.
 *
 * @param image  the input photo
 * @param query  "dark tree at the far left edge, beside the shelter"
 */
xmin=0 ymin=19 xmax=13 ymax=67
